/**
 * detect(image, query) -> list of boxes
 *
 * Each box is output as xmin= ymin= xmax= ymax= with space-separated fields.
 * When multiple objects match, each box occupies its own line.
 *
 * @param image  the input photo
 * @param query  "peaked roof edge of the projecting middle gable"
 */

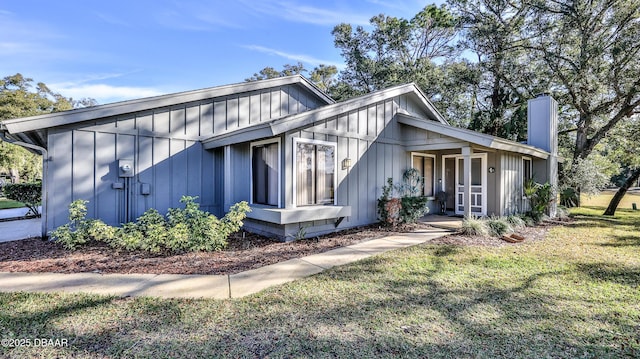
xmin=204 ymin=83 xmax=449 ymax=148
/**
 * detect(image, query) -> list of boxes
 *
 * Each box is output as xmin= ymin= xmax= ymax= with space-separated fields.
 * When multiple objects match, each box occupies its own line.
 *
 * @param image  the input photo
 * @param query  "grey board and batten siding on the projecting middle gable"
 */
xmin=283 ymin=95 xmax=426 ymax=229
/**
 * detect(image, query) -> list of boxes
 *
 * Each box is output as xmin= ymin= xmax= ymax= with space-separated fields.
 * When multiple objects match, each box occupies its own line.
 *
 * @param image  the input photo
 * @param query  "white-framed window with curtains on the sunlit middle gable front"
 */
xmin=293 ymin=140 xmax=336 ymax=206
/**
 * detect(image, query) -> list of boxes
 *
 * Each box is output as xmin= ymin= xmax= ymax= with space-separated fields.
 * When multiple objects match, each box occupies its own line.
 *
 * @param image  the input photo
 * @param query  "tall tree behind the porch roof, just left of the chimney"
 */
xmin=450 ymin=0 xmax=548 ymax=141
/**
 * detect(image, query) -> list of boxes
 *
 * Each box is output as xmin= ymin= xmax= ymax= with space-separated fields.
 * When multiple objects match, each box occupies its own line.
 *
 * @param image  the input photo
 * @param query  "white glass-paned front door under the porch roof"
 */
xmin=442 ymin=153 xmax=487 ymax=216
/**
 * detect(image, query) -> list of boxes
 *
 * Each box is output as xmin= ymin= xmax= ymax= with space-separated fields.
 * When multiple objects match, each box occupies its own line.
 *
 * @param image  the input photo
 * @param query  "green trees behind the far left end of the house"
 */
xmin=0 ymin=73 xmax=79 ymax=182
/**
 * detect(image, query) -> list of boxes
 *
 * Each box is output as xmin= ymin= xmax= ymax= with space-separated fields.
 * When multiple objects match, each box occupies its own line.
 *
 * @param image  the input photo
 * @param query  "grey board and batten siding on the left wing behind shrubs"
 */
xmin=46 ymin=84 xmax=322 ymax=230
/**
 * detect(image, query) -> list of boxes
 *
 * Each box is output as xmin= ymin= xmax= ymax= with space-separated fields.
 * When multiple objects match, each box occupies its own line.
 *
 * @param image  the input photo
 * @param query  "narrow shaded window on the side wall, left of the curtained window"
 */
xmin=251 ymin=140 xmax=280 ymax=206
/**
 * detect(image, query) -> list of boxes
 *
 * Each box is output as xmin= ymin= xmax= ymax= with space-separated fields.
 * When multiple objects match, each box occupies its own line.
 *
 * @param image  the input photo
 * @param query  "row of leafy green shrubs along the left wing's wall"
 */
xmin=51 ymin=196 xmax=250 ymax=253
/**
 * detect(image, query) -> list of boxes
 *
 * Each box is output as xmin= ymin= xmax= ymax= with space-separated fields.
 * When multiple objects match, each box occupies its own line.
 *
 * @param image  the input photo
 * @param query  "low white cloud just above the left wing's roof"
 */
xmin=49 ymin=83 xmax=166 ymax=104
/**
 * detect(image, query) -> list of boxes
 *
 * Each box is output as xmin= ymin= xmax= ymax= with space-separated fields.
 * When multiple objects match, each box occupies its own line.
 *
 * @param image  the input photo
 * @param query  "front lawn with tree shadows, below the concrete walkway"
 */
xmin=0 ymin=198 xmax=640 ymax=358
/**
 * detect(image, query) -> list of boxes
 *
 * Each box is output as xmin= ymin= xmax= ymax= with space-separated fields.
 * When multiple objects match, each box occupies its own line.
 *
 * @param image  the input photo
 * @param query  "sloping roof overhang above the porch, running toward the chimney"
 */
xmin=396 ymin=113 xmax=551 ymax=159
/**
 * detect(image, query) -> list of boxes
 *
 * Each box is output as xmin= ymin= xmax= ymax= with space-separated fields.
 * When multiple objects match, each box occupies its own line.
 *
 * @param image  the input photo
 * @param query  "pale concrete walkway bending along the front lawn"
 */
xmin=0 ymin=228 xmax=450 ymax=299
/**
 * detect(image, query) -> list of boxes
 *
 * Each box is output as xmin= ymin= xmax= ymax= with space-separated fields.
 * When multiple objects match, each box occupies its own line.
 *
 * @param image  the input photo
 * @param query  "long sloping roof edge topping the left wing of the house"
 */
xmin=2 ymin=75 xmax=335 ymax=134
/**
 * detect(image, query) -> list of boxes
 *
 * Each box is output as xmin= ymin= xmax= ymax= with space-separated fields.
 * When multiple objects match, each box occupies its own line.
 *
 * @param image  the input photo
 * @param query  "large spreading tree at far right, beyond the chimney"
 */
xmin=529 ymin=0 xmax=640 ymax=160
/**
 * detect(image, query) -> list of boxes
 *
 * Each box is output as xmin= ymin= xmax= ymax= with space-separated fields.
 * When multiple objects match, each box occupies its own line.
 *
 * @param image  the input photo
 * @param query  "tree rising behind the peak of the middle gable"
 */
xmin=331 ymin=5 xmax=479 ymax=121
